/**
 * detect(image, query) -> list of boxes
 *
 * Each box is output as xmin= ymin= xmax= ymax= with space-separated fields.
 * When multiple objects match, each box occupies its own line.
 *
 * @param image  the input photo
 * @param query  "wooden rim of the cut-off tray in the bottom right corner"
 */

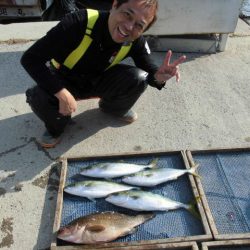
xmin=202 ymin=239 xmax=250 ymax=250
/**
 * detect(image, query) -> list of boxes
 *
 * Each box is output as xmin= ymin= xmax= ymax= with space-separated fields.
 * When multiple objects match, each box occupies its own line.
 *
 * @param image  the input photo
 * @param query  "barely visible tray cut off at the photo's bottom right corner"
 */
xmin=202 ymin=239 xmax=250 ymax=250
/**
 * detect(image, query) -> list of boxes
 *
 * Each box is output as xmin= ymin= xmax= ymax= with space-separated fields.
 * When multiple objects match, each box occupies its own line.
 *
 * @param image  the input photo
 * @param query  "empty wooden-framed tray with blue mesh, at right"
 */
xmin=186 ymin=148 xmax=250 ymax=241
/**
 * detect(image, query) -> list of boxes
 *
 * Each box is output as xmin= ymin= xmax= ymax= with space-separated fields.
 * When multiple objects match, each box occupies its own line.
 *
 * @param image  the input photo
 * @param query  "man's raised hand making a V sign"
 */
xmin=154 ymin=50 xmax=186 ymax=84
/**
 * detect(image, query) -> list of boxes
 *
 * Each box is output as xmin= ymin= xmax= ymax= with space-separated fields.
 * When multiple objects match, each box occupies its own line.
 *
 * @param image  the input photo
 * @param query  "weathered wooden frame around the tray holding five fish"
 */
xmin=51 ymin=151 xmax=212 ymax=250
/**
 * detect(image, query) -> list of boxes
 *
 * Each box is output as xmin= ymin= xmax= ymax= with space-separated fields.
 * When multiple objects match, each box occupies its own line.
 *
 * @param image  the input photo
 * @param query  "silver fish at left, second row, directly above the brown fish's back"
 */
xmin=64 ymin=180 xmax=138 ymax=200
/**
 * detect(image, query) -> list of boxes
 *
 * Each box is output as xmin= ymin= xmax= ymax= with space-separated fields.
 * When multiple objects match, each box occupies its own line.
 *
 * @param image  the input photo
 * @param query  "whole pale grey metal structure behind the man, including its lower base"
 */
xmin=146 ymin=0 xmax=242 ymax=53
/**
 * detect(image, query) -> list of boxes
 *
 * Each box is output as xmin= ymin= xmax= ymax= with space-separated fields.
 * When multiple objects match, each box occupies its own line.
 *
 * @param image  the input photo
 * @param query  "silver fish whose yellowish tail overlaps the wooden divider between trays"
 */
xmin=122 ymin=164 xmax=199 ymax=187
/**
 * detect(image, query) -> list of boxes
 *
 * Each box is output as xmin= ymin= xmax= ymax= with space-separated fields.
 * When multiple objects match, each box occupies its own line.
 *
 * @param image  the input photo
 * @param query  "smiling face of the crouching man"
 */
xmin=108 ymin=0 xmax=155 ymax=43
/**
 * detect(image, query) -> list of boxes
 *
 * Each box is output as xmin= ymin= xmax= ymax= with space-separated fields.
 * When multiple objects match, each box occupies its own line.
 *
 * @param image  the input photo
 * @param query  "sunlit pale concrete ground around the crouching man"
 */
xmin=0 ymin=19 xmax=250 ymax=250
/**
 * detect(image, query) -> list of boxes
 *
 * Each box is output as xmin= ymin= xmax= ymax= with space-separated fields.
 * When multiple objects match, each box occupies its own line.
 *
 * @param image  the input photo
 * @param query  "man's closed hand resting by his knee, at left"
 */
xmin=55 ymin=88 xmax=77 ymax=116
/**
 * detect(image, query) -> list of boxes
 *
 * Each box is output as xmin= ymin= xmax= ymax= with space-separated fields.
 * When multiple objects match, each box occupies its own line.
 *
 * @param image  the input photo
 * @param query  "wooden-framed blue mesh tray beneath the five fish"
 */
xmin=51 ymin=151 xmax=212 ymax=250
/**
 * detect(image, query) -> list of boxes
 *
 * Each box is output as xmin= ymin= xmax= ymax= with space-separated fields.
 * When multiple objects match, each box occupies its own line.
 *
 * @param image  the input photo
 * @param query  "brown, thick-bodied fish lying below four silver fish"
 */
xmin=57 ymin=211 xmax=155 ymax=244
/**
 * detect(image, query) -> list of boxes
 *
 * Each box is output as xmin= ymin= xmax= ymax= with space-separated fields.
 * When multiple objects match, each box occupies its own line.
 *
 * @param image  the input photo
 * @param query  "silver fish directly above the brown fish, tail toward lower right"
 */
xmin=105 ymin=190 xmax=197 ymax=214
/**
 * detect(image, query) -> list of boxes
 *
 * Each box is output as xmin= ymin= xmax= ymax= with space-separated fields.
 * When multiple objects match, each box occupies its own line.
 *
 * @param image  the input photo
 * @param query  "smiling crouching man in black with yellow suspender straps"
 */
xmin=21 ymin=0 xmax=185 ymax=148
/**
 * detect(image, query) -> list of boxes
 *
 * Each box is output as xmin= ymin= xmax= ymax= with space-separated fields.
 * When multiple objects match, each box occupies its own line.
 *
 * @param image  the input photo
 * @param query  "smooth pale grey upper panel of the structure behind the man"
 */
xmin=146 ymin=0 xmax=242 ymax=36
